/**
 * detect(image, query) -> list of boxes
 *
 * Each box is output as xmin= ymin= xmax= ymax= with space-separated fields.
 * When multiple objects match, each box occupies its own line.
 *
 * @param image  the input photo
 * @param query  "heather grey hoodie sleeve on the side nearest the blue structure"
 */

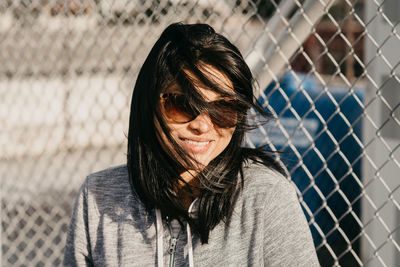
xmin=263 ymin=177 xmax=320 ymax=267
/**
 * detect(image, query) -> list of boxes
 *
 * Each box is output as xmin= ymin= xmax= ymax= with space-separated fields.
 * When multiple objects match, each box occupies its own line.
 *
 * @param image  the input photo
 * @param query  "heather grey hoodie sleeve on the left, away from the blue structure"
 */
xmin=63 ymin=180 xmax=93 ymax=266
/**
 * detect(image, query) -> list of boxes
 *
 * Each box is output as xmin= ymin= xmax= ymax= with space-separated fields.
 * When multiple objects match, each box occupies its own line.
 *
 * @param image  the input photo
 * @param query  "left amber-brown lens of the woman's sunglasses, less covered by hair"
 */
xmin=162 ymin=94 xmax=195 ymax=123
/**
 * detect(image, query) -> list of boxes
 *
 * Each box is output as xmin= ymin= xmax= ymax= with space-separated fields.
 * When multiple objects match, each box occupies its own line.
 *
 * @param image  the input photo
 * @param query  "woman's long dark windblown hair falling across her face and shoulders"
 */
xmin=128 ymin=23 xmax=282 ymax=243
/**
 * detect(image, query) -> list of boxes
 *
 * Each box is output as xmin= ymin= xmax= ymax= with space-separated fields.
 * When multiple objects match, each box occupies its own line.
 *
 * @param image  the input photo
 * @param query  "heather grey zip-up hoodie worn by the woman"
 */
xmin=64 ymin=163 xmax=319 ymax=267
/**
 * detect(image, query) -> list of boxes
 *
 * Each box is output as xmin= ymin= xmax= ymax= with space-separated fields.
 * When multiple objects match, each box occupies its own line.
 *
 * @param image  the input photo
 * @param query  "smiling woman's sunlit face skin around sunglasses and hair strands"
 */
xmin=161 ymin=66 xmax=235 ymax=169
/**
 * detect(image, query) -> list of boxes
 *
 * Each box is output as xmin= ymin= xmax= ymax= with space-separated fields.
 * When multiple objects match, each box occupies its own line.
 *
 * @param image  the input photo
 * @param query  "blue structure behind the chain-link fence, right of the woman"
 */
xmin=249 ymin=73 xmax=364 ymax=266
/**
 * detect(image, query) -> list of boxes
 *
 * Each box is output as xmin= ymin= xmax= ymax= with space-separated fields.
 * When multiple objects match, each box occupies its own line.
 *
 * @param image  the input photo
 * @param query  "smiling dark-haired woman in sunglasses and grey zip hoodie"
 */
xmin=64 ymin=23 xmax=318 ymax=266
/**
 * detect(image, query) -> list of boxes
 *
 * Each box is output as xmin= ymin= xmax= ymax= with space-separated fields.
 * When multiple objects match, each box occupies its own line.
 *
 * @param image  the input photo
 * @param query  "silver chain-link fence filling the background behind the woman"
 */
xmin=0 ymin=0 xmax=400 ymax=266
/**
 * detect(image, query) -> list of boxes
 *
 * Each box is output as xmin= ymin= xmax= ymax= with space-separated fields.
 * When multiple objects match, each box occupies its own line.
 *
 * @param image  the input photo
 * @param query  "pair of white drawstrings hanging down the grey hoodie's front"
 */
xmin=156 ymin=209 xmax=194 ymax=267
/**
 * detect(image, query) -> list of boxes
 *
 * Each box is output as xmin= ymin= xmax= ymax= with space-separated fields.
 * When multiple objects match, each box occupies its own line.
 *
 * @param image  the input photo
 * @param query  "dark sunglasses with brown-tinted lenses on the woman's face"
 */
xmin=160 ymin=93 xmax=244 ymax=128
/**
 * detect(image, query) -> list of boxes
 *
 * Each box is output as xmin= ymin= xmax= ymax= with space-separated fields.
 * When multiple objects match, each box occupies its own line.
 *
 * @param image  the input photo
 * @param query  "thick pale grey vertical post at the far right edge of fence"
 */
xmin=361 ymin=0 xmax=400 ymax=267
